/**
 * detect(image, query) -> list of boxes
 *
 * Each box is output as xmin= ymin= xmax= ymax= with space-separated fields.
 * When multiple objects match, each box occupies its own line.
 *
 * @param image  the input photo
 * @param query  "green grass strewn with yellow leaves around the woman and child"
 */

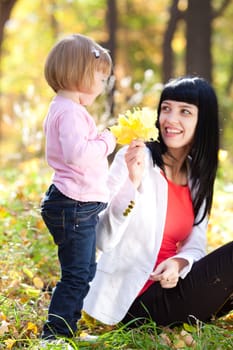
xmin=0 ymin=159 xmax=233 ymax=350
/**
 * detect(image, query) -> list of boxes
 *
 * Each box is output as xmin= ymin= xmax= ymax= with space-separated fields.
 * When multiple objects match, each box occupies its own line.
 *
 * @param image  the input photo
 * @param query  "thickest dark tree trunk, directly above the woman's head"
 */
xmin=186 ymin=0 xmax=212 ymax=82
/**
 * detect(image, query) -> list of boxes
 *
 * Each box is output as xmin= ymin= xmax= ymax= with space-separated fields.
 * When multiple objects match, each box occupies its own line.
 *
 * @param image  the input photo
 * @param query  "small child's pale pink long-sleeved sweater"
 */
xmin=44 ymin=95 xmax=116 ymax=202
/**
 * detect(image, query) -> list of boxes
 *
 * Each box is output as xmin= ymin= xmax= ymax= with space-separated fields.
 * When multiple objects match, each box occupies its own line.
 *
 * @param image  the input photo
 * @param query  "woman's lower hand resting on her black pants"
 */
xmin=150 ymin=258 xmax=188 ymax=288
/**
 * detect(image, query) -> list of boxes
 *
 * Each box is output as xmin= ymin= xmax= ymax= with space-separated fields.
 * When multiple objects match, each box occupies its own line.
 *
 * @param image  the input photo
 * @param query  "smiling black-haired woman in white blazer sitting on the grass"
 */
xmin=84 ymin=77 xmax=233 ymax=326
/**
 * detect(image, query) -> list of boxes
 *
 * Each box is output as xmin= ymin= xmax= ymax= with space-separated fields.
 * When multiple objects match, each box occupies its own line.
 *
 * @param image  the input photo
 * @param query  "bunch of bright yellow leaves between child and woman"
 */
xmin=110 ymin=107 xmax=158 ymax=145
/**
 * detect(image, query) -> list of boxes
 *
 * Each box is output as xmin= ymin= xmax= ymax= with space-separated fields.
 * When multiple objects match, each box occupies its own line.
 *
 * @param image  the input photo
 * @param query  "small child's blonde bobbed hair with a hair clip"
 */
xmin=44 ymin=34 xmax=112 ymax=93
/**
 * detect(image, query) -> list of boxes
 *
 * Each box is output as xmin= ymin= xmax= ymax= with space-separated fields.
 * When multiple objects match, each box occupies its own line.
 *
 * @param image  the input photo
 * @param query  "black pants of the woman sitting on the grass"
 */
xmin=122 ymin=242 xmax=233 ymax=327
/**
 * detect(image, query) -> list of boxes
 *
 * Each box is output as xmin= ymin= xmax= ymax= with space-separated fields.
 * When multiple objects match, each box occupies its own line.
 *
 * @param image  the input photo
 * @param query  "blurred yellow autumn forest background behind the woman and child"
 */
xmin=0 ymin=0 xmax=233 ymax=350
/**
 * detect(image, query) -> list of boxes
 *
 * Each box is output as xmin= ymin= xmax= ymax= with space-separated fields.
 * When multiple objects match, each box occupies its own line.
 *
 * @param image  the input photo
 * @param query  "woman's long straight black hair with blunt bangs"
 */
xmin=147 ymin=76 xmax=219 ymax=224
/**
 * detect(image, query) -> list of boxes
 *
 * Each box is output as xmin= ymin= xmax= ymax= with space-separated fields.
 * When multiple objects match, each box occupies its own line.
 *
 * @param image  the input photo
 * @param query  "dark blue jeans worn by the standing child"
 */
xmin=41 ymin=185 xmax=106 ymax=338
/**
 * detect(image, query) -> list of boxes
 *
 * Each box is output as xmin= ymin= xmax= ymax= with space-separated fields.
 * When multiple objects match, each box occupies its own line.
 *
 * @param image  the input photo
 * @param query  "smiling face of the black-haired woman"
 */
xmin=159 ymin=100 xmax=198 ymax=152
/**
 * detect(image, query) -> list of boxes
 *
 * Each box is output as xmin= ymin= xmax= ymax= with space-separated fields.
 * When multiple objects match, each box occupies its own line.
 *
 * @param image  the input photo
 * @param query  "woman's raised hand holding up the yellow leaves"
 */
xmin=125 ymin=140 xmax=146 ymax=189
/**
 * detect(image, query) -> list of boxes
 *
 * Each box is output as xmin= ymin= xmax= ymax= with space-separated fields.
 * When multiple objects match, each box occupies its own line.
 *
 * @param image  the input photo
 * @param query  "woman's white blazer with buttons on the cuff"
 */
xmin=83 ymin=147 xmax=207 ymax=325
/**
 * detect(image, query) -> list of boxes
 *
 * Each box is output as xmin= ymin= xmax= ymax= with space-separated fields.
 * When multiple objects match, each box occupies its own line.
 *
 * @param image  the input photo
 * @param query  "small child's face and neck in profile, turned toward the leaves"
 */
xmin=80 ymin=71 xmax=108 ymax=106
